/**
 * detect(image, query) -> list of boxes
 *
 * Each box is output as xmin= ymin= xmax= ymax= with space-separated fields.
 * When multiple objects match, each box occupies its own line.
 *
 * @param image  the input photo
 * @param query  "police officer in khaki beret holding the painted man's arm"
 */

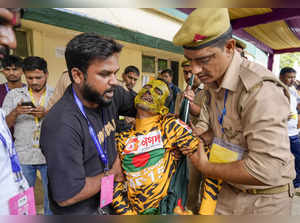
xmin=173 ymin=8 xmax=295 ymax=215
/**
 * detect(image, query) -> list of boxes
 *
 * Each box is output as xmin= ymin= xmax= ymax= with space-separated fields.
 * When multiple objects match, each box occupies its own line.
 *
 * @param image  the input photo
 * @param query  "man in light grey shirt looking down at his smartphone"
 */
xmin=2 ymin=57 xmax=53 ymax=215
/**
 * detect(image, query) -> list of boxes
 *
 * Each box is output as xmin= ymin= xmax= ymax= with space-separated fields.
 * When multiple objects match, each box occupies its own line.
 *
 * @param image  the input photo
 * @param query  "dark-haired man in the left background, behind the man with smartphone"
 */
xmin=0 ymin=55 xmax=25 ymax=107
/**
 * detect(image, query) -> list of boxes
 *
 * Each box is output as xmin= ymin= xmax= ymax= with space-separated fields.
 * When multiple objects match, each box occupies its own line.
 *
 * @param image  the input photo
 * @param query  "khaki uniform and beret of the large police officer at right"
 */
xmin=173 ymin=8 xmax=295 ymax=215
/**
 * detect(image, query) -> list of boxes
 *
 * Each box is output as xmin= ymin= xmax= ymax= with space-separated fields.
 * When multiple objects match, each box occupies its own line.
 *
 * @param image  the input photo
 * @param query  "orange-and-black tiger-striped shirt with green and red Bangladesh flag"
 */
xmin=113 ymin=116 xmax=199 ymax=214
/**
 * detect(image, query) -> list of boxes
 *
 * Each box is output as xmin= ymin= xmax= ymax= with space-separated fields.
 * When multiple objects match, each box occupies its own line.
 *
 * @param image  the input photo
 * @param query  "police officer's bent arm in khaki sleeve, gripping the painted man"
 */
xmin=183 ymin=82 xmax=293 ymax=186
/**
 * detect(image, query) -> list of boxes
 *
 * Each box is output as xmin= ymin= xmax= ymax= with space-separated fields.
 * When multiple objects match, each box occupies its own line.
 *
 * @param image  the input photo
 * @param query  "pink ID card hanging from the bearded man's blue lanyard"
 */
xmin=100 ymin=175 xmax=114 ymax=208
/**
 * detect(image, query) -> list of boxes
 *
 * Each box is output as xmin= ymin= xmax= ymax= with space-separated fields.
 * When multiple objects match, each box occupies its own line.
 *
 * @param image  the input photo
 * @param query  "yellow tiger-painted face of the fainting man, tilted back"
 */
xmin=135 ymin=80 xmax=170 ymax=115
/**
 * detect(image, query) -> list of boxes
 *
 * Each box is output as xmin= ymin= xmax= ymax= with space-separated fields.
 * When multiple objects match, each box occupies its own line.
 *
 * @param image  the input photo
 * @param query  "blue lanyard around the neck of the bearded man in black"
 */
xmin=72 ymin=88 xmax=109 ymax=171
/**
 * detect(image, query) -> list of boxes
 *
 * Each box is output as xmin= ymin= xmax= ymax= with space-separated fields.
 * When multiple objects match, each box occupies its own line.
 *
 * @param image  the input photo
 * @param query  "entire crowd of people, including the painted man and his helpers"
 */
xmin=0 ymin=8 xmax=300 ymax=215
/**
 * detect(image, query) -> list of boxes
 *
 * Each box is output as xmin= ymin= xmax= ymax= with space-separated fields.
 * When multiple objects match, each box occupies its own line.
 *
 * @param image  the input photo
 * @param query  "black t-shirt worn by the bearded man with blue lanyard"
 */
xmin=40 ymin=85 xmax=136 ymax=215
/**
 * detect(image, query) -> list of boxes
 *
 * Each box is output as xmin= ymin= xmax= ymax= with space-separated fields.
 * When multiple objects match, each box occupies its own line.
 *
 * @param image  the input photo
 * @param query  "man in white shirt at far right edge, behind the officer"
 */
xmin=279 ymin=67 xmax=300 ymax=196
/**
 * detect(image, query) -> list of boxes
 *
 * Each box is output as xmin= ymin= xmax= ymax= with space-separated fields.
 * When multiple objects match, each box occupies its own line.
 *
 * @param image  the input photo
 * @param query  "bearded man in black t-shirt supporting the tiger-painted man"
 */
xmin=40 ymin=33 xmax=136 ymax=215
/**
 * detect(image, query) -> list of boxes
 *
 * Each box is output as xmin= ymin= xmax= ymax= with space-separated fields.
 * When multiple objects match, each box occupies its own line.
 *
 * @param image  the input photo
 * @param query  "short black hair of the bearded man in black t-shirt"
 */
xmin=65 ymin=33 xmax=123 ymax=82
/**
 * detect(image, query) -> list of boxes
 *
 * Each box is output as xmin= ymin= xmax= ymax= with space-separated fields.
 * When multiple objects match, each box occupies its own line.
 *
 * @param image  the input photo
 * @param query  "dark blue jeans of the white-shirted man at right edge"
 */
xmin=290 ymin=135 xmax=300 ymax=188
